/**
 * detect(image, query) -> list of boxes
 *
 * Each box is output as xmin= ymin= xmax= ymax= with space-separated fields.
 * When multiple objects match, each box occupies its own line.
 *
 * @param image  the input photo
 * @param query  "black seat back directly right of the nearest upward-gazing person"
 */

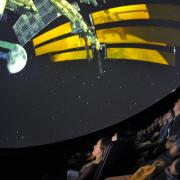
xmin=93 ymin=139 xmax=136 ymax=180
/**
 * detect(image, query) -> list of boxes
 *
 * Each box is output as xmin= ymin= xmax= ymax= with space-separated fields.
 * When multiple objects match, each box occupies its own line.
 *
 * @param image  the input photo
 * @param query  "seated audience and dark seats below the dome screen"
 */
xmin=41 ymin=99 xmax=180 ymax=180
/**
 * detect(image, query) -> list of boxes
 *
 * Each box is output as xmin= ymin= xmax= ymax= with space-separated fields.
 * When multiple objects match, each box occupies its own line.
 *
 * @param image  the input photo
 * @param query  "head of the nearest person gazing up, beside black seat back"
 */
xmin=92 ymin=138 xmax=111 ymax=160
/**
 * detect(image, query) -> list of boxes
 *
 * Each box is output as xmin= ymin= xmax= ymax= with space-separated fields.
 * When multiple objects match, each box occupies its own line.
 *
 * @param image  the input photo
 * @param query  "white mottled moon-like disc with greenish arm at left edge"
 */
xmin=0 ymin=41 xmax=27 ymax=74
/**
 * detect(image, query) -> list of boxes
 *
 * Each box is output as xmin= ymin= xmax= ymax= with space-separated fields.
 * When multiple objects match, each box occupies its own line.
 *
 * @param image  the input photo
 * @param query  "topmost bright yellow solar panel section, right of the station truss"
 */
xmin=92 ymin=4 xmax=150 ymax=25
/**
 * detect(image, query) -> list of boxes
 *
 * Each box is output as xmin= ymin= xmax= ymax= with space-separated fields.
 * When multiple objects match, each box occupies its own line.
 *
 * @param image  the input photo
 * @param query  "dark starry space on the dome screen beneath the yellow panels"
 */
xmin=0 ymin=0 xmax=180 ymax=148
